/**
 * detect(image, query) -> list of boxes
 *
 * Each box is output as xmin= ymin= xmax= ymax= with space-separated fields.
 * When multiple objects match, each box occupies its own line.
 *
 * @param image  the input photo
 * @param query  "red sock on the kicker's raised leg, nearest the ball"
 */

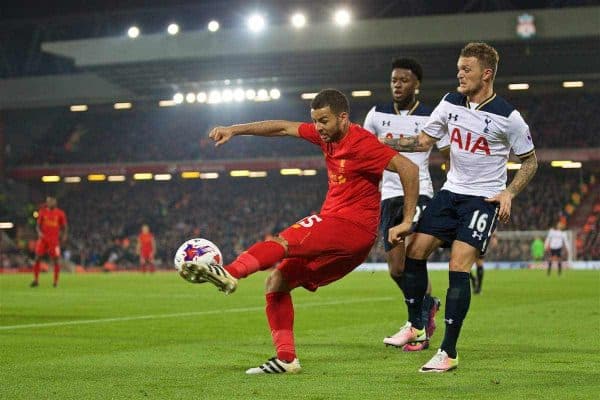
xmin=225 ymin=240 xmax=285 ymax=279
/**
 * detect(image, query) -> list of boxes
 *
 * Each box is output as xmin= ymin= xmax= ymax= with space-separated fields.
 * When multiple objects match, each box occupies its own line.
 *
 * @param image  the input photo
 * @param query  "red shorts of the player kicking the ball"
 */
xmin=277 ymin=215 xmax=376 ymax=292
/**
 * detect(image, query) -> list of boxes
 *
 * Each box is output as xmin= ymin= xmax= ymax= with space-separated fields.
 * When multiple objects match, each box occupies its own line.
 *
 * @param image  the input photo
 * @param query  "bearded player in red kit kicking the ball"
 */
xmin=182 ymin=89 xmax=419 ymax=374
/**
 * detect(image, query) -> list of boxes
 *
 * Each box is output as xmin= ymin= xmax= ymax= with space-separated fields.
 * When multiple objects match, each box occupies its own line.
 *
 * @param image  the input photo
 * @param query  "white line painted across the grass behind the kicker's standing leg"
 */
xmin=0 ymin=297 xmax=393 ymax=331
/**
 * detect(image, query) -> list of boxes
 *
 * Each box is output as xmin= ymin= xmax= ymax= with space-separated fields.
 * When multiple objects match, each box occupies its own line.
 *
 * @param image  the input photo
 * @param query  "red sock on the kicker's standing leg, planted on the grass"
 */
xmin=266 ymin=292 xmax=296 ymax=362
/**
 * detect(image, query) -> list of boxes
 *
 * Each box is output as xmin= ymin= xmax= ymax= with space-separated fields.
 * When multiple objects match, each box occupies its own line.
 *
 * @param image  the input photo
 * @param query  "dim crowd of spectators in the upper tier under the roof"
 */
xmin=5 ymin=93 xmax=600 ymax=166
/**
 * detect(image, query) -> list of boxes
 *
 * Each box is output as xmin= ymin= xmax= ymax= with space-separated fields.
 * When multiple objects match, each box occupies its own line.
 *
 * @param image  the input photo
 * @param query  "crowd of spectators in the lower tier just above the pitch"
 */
xmin=2 ymin=164 xmax=592 ymax=268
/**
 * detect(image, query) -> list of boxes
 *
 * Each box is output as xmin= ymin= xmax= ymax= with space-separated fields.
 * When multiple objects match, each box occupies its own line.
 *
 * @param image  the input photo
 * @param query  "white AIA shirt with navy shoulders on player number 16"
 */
xmin=423 ymin=93 xmax=535 ymax=197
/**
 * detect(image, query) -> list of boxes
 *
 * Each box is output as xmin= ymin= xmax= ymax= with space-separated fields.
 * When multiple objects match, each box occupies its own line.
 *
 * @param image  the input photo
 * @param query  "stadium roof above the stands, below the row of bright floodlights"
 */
xmin=0 ymin=7 xmax=600 ymax=108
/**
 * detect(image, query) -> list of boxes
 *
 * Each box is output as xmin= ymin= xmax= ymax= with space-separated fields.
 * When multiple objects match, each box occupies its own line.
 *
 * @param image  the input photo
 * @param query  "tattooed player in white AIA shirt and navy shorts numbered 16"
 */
xmin=386 ymin=43 xmax=537 ymax=372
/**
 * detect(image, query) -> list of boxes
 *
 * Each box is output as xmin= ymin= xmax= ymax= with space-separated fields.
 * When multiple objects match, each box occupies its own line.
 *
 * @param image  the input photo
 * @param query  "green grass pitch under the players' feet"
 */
xmin=0 ymin=270 xmax=600 ymax=400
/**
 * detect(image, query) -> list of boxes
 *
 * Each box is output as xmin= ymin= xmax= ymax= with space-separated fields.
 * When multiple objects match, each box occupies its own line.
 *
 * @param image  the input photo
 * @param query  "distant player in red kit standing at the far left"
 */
xmin=30 ymin=196 xmax=68 ymax=287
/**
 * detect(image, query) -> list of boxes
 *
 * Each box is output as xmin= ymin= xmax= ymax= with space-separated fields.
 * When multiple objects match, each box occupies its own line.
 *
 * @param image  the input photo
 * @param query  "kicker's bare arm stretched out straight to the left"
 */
xmin=208 ymin=120 xmax=301 ymax=146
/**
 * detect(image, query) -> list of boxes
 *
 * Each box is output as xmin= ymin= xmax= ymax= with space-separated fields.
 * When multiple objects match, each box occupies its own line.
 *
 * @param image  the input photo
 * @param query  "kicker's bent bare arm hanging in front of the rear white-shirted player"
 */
xmin=387 ymin=154 xmax=419 ymax=245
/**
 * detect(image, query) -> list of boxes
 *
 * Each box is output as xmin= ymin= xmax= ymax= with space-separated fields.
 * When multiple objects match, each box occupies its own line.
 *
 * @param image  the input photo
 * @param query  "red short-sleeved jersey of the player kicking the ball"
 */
xmin=298 ymin=123 xmax=398 ymax=235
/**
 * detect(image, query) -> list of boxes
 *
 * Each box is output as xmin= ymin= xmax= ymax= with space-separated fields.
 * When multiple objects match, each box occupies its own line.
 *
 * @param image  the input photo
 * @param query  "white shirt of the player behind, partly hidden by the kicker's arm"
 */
xmin=364 ymin=101 xmax=449 ymax=200
